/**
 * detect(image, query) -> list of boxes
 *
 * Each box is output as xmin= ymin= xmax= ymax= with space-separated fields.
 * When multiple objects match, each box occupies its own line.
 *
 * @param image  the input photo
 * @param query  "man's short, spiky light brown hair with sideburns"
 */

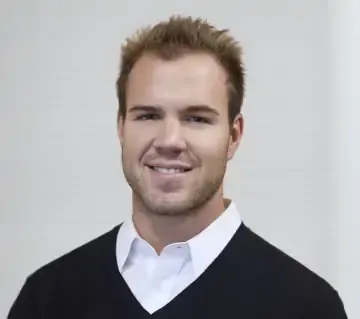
xmin=116 ymin=16 xmax=245 ymax=123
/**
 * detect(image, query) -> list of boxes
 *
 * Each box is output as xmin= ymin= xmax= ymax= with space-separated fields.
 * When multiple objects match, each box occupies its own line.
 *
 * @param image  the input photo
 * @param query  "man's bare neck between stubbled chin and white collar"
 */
xmin=133 ymin=190 xmax=228 ymax=254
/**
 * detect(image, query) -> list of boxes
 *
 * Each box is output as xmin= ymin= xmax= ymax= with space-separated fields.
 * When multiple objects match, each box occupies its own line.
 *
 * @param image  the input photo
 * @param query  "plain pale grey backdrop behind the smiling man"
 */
xmin=0 ymin=0 xmax=360 ymax=319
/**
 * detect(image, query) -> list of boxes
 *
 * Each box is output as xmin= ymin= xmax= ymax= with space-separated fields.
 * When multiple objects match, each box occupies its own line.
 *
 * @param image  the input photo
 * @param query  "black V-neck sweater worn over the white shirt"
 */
xmin=8 ymin=224 xmax=347 ymax=319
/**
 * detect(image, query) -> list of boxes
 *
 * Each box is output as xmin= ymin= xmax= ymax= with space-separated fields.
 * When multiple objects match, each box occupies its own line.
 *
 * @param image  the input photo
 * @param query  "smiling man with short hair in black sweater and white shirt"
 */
xmin=9 ymin=17 xmax=346 ymax=319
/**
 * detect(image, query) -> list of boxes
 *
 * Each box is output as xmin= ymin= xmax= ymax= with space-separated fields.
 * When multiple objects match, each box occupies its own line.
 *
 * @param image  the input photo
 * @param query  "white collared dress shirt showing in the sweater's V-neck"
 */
xmin=116 ymin=202 xmax=241 ymax=314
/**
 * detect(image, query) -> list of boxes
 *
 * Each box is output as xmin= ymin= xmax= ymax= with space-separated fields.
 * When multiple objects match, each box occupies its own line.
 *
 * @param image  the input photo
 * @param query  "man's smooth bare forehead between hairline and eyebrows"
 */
xmin=127 ymin=53 xmax=228 ymax=111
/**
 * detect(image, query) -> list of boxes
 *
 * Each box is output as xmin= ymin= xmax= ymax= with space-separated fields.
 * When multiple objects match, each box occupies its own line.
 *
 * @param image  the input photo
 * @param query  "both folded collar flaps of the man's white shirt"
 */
xmin=116 ymin=200 xmax=241 ymax=276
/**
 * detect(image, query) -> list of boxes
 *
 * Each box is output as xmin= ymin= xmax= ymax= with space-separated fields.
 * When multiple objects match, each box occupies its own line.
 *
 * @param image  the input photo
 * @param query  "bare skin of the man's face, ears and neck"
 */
xmin=118 ymin=53 xmax=243 ymax=254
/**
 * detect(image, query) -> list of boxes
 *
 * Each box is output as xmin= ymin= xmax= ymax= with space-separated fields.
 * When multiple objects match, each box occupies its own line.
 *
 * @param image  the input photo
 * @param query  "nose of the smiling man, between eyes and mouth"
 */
xmin=153 ymin=119 xmax=186 ymax=154
